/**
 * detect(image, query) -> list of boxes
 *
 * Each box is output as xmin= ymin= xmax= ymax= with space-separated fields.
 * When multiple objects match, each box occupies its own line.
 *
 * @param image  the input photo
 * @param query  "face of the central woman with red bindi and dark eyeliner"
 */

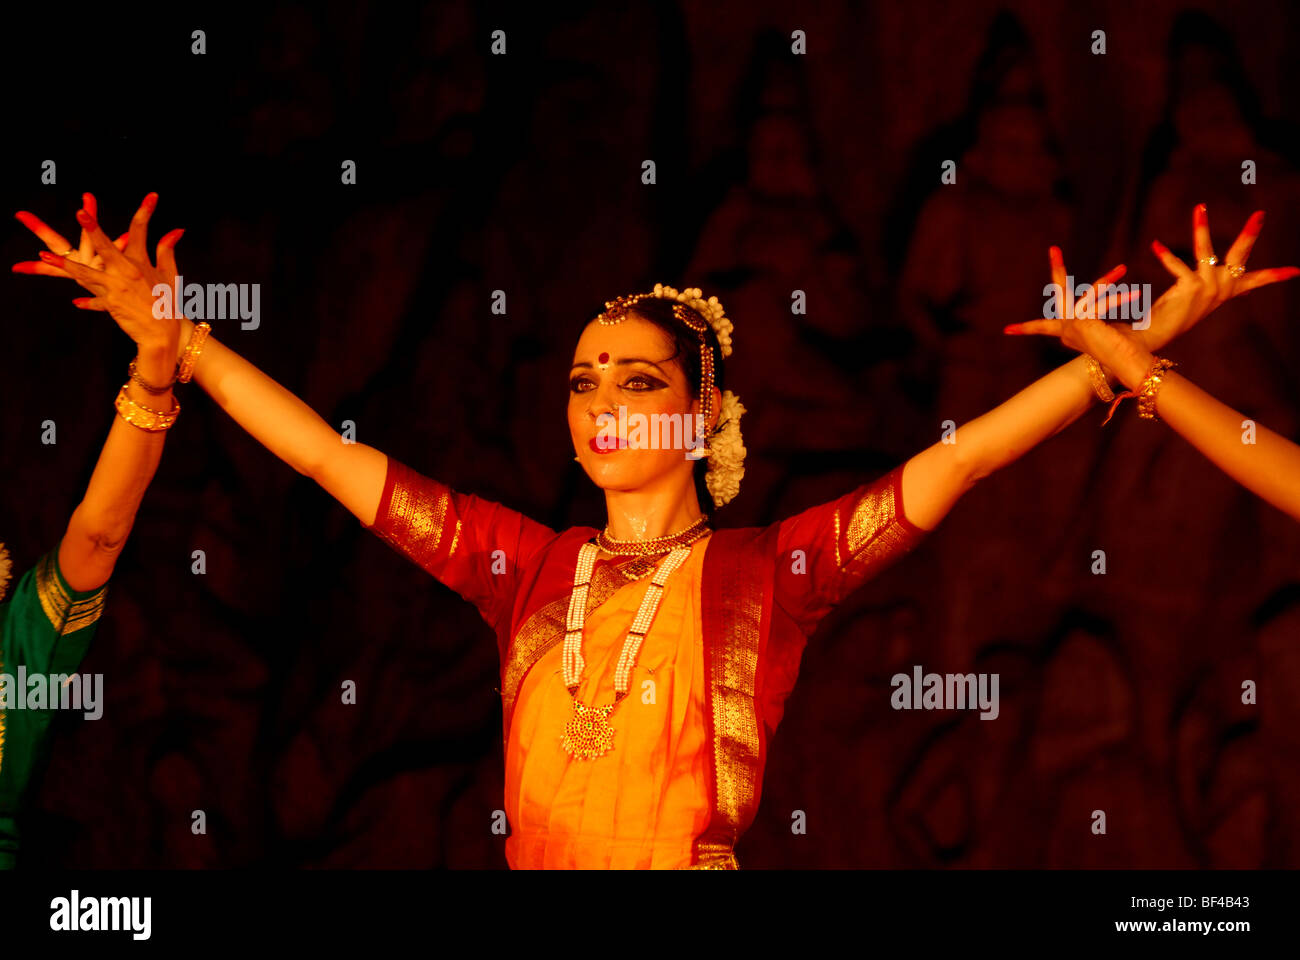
xmin=568 ymin=315 xmax=722 ymax=490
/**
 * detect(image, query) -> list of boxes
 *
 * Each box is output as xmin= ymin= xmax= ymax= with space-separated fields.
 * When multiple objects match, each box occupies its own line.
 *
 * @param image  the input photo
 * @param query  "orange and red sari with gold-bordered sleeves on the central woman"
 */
xmin=369 ymin=458 xmax=924 ymax=869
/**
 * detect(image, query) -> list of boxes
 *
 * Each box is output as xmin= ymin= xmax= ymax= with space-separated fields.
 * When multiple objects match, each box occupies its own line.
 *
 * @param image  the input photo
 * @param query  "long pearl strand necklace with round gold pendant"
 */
xmin=560 ymin=518 xmax=709 ymax=760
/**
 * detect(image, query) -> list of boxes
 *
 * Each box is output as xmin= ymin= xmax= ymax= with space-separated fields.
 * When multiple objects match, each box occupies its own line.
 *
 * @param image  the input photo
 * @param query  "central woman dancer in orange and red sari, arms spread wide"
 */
xmin=18 ymin=196 xmax=1294 ymax=869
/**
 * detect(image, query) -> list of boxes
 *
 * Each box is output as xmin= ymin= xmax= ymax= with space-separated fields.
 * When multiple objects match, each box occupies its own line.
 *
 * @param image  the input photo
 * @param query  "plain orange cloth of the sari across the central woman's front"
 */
xmin=506 ymin=540 xmax=709 ymax=869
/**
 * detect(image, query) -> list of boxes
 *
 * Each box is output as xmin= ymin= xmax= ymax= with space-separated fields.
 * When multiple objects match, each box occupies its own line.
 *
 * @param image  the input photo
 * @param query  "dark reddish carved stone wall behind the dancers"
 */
xmin=0 ymin=1 xmax=1300 ymax=868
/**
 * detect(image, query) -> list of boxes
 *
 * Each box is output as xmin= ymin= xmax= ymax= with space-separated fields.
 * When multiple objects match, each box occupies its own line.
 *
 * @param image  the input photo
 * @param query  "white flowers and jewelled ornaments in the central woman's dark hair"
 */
xmin=595 ymin=284 xmax=746 ymax=507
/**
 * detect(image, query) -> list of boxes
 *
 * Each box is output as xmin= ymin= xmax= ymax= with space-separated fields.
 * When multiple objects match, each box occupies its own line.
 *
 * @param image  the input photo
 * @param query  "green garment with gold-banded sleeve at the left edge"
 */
xmin=0 ymin=545 xmax=108 ymax=869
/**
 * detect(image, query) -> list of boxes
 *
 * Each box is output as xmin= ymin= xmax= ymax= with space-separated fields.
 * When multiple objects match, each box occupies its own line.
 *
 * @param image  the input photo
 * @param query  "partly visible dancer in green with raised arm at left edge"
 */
xmin=0 ymin=194 xmax=181 ymax=869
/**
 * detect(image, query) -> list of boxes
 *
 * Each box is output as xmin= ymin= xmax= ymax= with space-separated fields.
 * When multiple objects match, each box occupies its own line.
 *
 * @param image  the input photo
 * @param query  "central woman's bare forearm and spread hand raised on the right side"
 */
xmin=902 ymin=206 xmax=1300 ymax=529
